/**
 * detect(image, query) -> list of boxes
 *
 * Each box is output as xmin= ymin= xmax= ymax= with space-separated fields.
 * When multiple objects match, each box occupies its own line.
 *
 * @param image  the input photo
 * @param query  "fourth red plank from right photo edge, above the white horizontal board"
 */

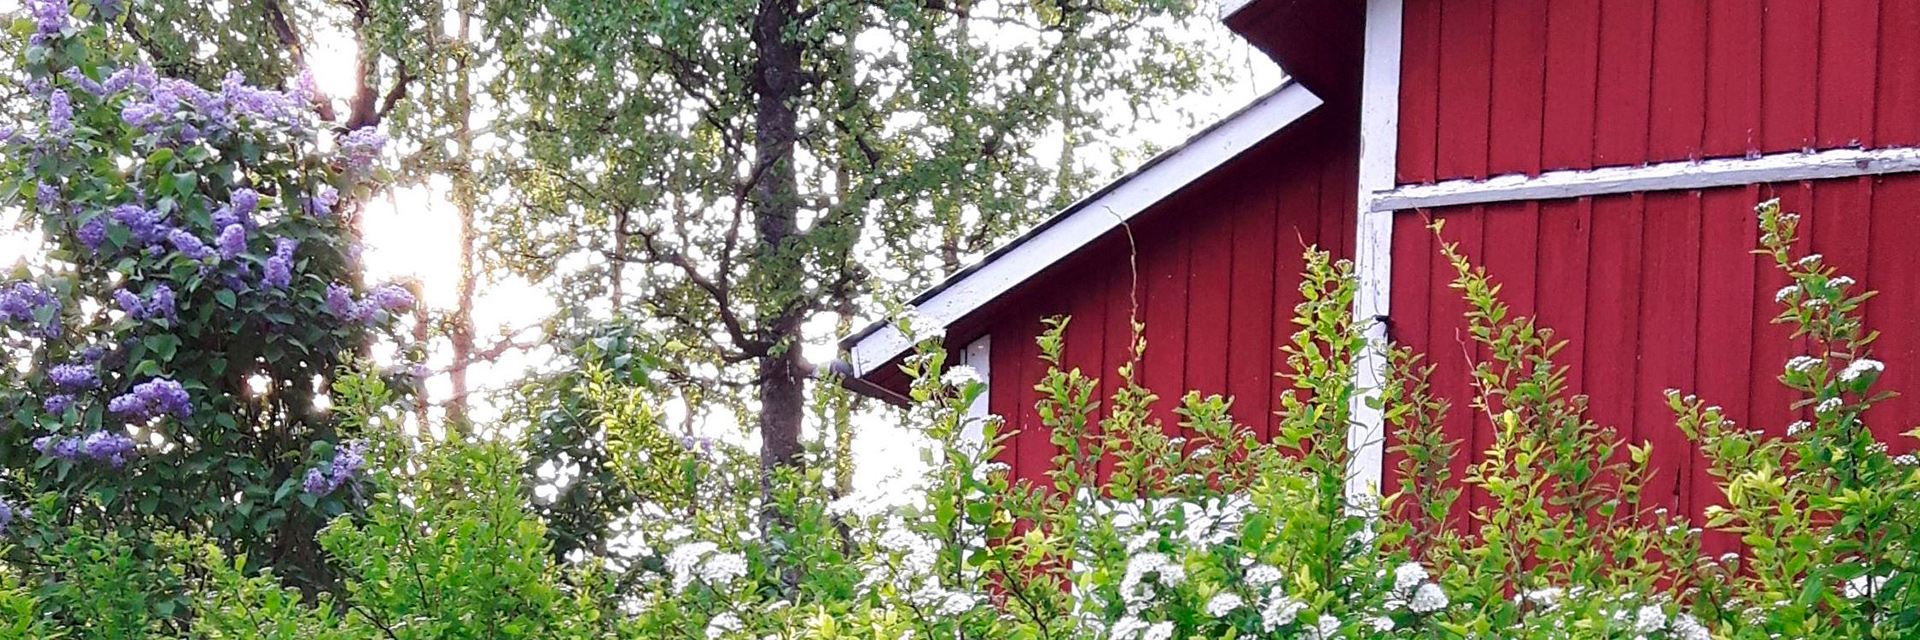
xmin=1705 ymin=0 xmax=1763 ymax=158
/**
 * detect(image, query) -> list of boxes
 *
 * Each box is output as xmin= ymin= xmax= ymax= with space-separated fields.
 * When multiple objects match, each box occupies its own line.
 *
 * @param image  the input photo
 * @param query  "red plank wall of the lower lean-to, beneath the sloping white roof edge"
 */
xmin=975 ymin=111 xmax=1357 ymax=479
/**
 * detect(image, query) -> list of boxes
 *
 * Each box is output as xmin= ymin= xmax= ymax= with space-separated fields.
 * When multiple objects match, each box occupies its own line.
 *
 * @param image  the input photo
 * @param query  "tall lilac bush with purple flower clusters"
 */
xmin=0 ymin=0 xmax=413 ymax=580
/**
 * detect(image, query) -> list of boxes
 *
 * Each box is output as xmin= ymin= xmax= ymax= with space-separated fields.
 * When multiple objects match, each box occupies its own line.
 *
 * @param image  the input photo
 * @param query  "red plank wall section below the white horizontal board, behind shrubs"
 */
xmin=1388 ymin=175 xmax=1920 ymax=544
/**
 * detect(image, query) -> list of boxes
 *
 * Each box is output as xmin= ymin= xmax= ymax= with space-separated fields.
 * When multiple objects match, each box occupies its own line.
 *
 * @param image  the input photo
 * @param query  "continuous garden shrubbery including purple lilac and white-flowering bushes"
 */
xmin=0 ymin=0 xmax=1920 ymax=640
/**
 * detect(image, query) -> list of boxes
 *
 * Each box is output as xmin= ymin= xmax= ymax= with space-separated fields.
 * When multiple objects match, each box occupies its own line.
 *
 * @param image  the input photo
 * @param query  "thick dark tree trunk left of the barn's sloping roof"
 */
xmin=753 ymin=0 xmax=806 ymax=472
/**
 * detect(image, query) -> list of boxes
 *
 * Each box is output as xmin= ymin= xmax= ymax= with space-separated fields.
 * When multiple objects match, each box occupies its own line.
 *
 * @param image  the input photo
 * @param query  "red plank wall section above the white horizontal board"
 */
xmin=1398 ymin=0 xmax=1920 ymax=183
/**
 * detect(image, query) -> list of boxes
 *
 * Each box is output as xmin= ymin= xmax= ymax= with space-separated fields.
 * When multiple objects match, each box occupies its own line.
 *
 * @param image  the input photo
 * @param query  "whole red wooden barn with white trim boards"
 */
xmin=845 ymin=0 xmax=1920 ymax=530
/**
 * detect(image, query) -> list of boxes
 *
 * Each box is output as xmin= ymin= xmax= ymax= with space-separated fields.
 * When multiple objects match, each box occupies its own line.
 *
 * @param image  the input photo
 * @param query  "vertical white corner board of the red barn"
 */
xmin=1346 ymin=0 xmax=1402 ymax=504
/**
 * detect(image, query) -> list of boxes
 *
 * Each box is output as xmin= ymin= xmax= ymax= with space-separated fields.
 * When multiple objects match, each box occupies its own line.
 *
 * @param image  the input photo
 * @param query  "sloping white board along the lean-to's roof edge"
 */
xmin=847 ymin=83 xmax=1321 ymax=377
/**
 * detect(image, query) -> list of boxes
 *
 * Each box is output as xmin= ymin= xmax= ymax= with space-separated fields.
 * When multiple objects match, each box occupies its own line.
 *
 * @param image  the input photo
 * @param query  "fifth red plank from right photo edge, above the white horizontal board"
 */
xmin=1647 ymin=2 xmax=1704 ymax=161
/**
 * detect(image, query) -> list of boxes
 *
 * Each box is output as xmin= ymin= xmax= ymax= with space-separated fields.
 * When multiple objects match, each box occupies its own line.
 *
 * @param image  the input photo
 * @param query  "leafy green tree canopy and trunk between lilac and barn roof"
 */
xmin=486 ymin=0 xmax=1208 ymax=495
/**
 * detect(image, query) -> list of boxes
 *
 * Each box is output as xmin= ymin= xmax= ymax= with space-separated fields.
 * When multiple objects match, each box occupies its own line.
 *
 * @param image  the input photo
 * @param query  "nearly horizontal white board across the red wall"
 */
xmin=1371 ymin=146 xmax=1920 ymax=211
